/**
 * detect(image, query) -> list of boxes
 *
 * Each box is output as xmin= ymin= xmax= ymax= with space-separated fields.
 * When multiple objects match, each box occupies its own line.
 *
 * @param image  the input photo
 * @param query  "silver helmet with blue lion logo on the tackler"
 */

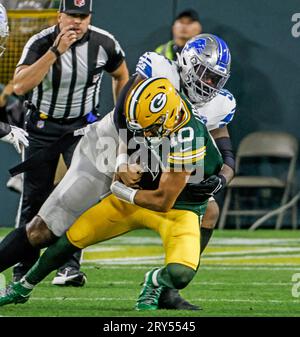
xmin=177 ymin=34 xmax=231 ymax=103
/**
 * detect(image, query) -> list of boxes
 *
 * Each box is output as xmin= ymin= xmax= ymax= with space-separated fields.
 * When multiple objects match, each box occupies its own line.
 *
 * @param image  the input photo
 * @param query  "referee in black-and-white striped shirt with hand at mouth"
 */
xmin=13 ymin=0 xmax=128 ymax=286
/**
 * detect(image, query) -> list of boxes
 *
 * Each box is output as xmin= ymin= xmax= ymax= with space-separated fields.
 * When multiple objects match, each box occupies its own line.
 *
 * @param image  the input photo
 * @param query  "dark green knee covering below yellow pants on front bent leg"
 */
xmin=167 ymin=263 xmax=196 ymax=289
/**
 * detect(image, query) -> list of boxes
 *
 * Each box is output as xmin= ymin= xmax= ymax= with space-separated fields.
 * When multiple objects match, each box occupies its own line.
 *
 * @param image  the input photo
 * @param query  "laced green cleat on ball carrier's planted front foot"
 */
xmin=135 ymin=268 xmax=164 ymax=310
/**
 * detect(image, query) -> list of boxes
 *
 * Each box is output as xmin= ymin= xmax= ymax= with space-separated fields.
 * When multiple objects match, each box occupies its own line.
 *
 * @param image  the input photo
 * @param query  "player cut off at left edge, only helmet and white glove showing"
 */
xmin=0 ymin=4 xmax=28 ymax=153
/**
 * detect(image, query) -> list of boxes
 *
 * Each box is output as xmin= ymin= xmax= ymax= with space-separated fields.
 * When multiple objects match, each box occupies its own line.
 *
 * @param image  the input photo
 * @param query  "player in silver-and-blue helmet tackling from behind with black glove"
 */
xmin=178 ymin=34 xmax=236 ymax=253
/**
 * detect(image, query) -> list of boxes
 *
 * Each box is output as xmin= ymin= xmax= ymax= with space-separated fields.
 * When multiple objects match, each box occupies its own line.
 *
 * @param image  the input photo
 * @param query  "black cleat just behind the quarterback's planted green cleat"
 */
xmin=158 ymin=287 xmax=202 ymax=310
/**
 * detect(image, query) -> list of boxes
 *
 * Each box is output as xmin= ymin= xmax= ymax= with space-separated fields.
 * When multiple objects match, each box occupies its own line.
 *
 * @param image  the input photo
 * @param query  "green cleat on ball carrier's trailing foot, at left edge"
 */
xmin=0 ymin=282 xmax=31 ymax=307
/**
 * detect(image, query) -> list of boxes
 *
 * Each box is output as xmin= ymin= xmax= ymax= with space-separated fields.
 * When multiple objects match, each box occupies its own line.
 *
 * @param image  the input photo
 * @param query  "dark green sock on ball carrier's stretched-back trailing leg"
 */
xmin=25 ymin=234 xmax=80 ymax=285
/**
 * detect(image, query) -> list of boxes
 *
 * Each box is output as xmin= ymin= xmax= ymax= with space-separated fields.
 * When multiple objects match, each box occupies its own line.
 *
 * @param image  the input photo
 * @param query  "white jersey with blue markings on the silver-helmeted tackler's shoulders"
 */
xmin=136 ymin=52 xmax=236 ymax=130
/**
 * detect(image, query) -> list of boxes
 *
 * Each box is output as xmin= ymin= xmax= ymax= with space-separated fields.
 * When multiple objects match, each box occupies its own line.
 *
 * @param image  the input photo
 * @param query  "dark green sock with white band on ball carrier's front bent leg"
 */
xmin=152 ymin=263 xmax=196 ymax=289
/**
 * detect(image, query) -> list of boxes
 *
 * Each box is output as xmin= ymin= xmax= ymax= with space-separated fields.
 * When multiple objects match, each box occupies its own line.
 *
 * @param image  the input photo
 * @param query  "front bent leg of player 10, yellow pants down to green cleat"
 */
xmin=136 ymin=210 xmax=200 ymax=310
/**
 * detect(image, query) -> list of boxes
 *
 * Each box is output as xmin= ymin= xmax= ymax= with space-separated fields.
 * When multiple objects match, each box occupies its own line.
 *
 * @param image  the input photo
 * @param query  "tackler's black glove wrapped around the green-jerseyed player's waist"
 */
xmin=188 ymin=174 xmax=226 ymax=202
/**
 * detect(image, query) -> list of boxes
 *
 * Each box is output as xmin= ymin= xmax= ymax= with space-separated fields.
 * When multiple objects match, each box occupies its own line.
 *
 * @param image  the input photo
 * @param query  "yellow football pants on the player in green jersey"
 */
xmin=67 ymin=195 xmax=200 ymax=270
